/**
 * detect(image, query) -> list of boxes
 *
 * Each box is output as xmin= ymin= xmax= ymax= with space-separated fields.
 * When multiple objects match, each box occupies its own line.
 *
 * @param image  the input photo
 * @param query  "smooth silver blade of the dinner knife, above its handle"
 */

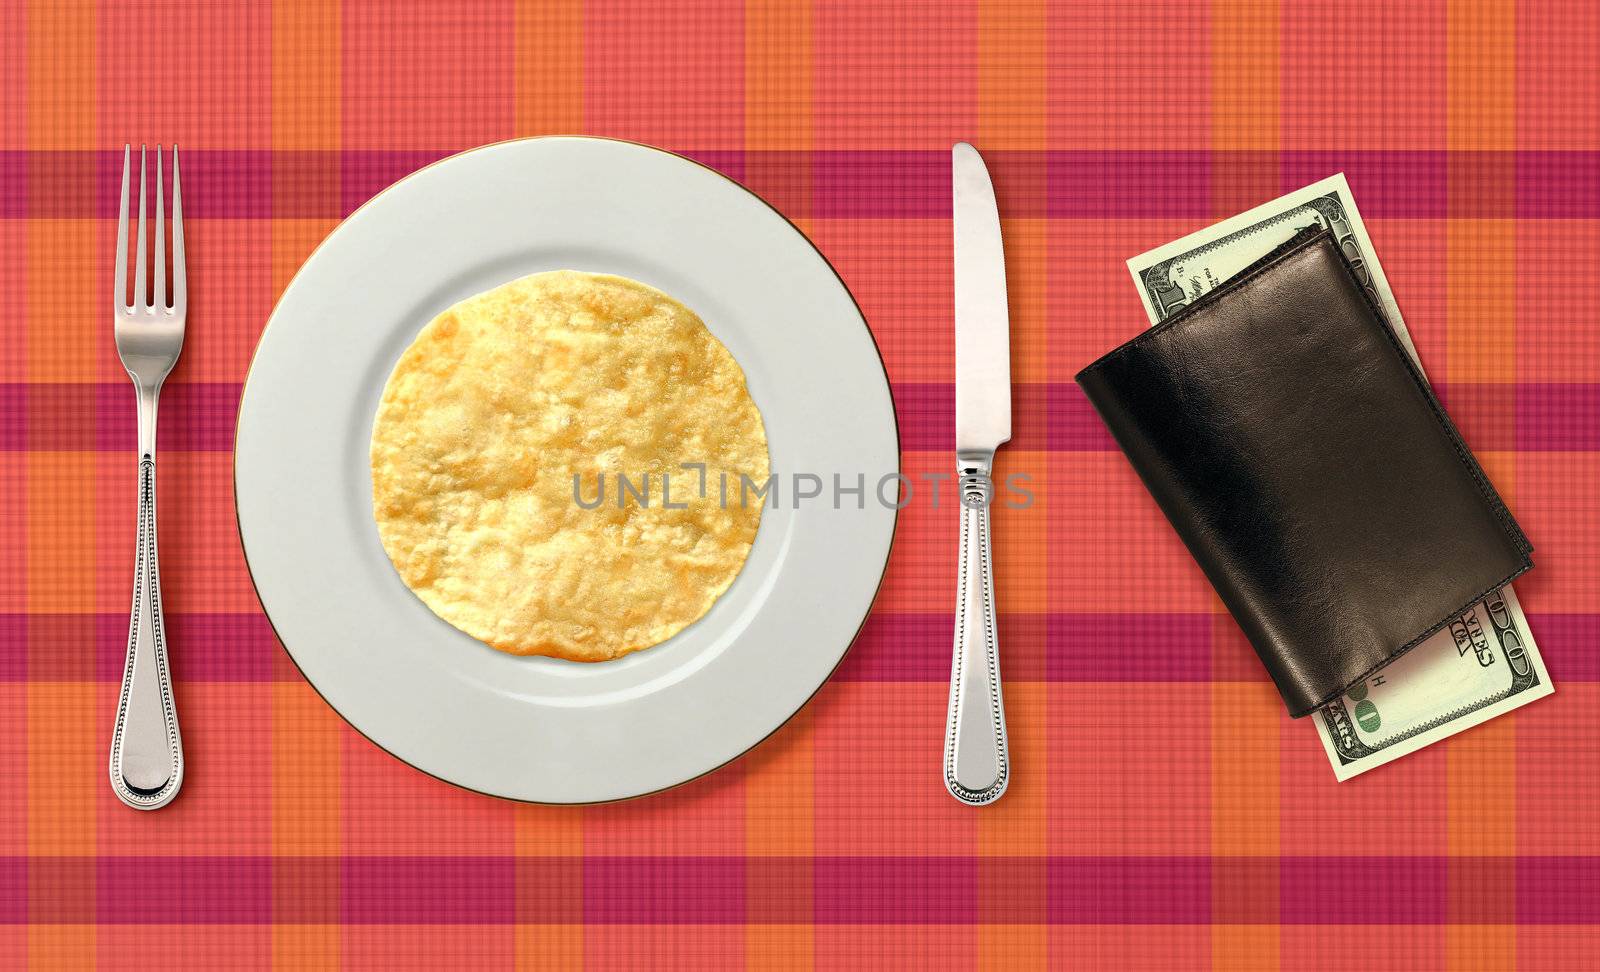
xmin=950 ymin=142 xmax=1011 ymax=452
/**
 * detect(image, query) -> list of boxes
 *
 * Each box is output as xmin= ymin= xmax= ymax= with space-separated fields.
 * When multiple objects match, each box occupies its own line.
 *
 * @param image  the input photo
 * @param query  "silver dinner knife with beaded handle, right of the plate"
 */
xmin=944 ymin=142 xmax=1011 ymax=806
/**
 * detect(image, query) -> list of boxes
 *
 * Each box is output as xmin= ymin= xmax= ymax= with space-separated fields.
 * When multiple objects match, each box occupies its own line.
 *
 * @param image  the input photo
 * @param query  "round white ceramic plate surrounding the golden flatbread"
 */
xmin=234 ymin=137 xmax=899 ymax=803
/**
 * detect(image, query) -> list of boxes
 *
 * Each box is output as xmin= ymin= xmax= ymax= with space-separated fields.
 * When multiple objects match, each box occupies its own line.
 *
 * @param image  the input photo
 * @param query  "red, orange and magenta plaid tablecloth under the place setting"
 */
xmin=0 ymin=0 xmax=1600 ymax=969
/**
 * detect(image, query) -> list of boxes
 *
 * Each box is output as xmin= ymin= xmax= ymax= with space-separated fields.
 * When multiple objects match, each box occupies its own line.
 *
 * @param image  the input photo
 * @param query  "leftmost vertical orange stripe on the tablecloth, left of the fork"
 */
xmin=25 ymin=0 xmax=100 ymax=908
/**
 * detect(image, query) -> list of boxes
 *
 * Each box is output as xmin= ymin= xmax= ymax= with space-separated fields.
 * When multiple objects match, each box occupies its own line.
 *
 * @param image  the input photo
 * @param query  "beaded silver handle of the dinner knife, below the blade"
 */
xmin=944 ymin=452 xmax=1011 ymax=806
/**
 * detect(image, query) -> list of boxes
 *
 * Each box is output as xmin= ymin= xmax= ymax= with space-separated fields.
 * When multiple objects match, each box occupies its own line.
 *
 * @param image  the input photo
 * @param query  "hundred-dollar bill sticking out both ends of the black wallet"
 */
xmin=1128 ymin=173 xmax=1555 ymax=780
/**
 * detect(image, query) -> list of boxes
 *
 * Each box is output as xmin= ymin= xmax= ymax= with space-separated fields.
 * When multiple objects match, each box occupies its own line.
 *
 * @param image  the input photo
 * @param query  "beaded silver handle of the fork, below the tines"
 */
xmin=110 ymin=387 xmax=184 ymax=811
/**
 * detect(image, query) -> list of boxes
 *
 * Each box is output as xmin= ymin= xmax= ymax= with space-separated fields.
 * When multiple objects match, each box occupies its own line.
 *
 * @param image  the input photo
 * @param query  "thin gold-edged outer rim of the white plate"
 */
xmin=229 ymin=133 xmax=906 ymax=807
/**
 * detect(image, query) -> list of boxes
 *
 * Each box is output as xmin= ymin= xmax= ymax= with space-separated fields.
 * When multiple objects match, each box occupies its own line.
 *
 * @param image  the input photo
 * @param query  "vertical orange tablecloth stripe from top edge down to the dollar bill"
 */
xmin=1211 ymin=0 xmax=1282 ymax=217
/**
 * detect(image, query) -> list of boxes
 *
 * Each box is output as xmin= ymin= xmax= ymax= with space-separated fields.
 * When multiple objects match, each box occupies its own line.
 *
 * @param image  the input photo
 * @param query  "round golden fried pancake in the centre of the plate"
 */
xmin=371 ymin=270 xmax=768 ymax=662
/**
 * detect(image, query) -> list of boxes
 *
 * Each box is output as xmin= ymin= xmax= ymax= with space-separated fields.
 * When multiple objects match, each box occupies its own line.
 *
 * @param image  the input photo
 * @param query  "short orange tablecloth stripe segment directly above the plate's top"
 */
xmin=512 ymin=0 xmax=584 ymax=136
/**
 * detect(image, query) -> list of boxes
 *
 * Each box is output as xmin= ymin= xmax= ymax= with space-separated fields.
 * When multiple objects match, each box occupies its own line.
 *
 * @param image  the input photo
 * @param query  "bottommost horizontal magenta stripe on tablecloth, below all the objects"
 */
xmin=9 ymin=855 xmax=1600 ymax=926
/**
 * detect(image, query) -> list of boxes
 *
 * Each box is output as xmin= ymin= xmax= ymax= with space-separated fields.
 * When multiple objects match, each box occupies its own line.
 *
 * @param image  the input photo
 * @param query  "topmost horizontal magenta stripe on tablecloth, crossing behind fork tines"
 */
xmin=0 ymin=145 xmax=1600 ymax=220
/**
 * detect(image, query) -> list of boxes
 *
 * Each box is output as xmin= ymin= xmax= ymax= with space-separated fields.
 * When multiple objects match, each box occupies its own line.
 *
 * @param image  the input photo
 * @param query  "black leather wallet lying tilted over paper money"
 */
xmin=1077 ymin=230 xmax=1533 ymax=718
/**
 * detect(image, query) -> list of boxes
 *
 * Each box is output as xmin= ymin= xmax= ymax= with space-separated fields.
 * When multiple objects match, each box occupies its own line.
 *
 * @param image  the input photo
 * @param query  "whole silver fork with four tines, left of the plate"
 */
xmin=110 ymin=145 xmax=189 ymax=811
